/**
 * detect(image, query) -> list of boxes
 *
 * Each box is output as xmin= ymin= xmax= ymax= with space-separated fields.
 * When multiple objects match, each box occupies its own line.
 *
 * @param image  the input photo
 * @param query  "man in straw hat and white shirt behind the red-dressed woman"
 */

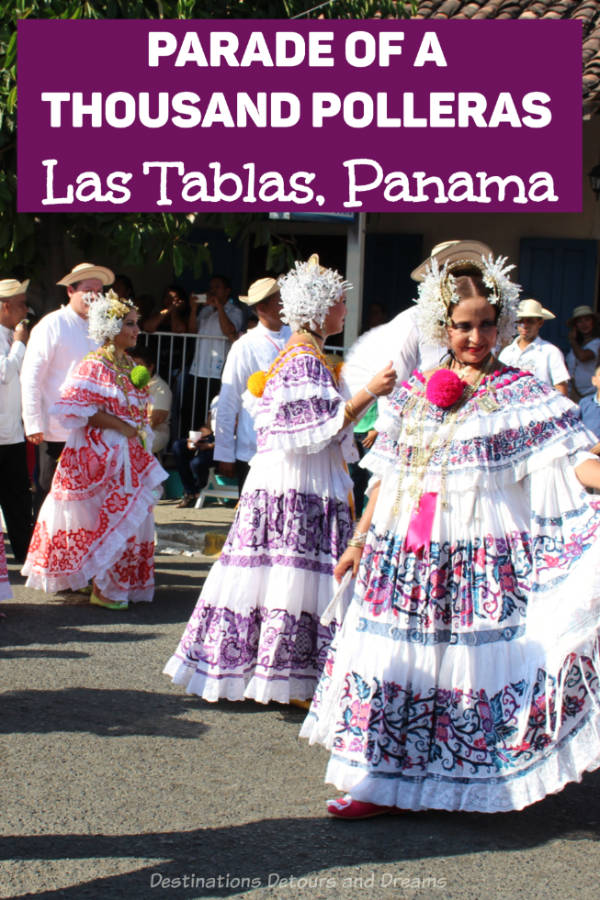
xmin=21 ymin=263 xmax=115 ymax=493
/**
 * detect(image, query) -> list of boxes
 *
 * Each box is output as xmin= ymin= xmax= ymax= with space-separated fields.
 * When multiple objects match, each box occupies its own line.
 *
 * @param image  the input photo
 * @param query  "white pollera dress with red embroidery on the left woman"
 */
xmin=23 ymin=349 xmax=167 ymax=602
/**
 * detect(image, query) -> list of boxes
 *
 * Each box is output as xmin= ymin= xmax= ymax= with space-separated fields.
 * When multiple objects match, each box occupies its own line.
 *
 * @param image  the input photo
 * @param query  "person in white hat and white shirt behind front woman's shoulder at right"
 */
xmin=499 ymin=297 xmax=570 ymax=397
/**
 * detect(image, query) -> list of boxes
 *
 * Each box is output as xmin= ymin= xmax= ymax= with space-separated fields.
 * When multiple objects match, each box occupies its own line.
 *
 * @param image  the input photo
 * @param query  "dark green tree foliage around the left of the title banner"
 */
xmin=0 ymin=0 xmax=414 ymax=286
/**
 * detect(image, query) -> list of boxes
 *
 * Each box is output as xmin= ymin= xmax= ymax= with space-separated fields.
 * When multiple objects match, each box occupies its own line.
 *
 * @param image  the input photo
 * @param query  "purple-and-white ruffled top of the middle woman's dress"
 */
xmin=253 ymin=345 xmax=344 ymax=453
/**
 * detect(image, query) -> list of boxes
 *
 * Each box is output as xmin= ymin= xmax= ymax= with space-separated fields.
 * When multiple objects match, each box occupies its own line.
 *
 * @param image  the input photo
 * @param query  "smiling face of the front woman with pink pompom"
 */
xmin=448 ymin=297 xmax=498 ymax=366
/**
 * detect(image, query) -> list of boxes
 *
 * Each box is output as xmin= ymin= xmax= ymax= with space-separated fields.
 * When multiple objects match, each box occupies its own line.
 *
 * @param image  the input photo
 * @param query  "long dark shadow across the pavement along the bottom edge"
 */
xmin=0 ymin=775 xmax=600 ymax=900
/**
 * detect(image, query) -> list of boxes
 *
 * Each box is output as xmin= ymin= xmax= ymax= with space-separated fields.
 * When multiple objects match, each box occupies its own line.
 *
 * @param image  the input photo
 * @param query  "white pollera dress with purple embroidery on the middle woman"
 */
xmin=165 ymin=345 xmax=352 ymax=703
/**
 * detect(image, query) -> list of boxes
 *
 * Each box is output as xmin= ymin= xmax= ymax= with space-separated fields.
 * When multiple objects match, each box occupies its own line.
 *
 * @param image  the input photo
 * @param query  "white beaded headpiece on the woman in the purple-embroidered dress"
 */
xmin=279 ymin=253 xmax=352 ymax=331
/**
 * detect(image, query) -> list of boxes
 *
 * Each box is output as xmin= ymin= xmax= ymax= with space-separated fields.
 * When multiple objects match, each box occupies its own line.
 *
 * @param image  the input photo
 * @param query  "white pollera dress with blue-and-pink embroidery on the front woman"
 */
xmin=301 ymin=369 xmax=600 ymax=812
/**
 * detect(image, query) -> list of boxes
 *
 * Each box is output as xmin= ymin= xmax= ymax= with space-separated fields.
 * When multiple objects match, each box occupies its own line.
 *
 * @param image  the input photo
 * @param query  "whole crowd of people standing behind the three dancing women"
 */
xmin=0 ymin=250 xmax=600 ymax=561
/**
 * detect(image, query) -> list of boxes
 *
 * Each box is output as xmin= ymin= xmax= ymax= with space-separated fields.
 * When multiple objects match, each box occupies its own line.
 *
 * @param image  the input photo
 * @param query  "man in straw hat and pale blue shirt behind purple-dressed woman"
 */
xmin=214 ymin=278 xmax=291 ymax=491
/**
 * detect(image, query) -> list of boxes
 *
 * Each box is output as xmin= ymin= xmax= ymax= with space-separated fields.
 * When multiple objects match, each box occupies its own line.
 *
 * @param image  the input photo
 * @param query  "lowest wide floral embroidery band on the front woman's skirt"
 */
xmin=328 ymin=657 xmax=600 ymax=782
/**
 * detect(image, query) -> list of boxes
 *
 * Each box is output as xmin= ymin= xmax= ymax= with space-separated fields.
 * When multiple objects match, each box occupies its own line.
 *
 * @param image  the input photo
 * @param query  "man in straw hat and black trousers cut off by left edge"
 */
xmin=0 ymin=278 xmax=31 ymax=563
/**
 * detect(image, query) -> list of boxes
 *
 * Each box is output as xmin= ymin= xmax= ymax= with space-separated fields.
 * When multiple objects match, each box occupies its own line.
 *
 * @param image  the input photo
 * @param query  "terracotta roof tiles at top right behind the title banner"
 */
xmin=414 ymin=0 xmax=600 ymax=116
